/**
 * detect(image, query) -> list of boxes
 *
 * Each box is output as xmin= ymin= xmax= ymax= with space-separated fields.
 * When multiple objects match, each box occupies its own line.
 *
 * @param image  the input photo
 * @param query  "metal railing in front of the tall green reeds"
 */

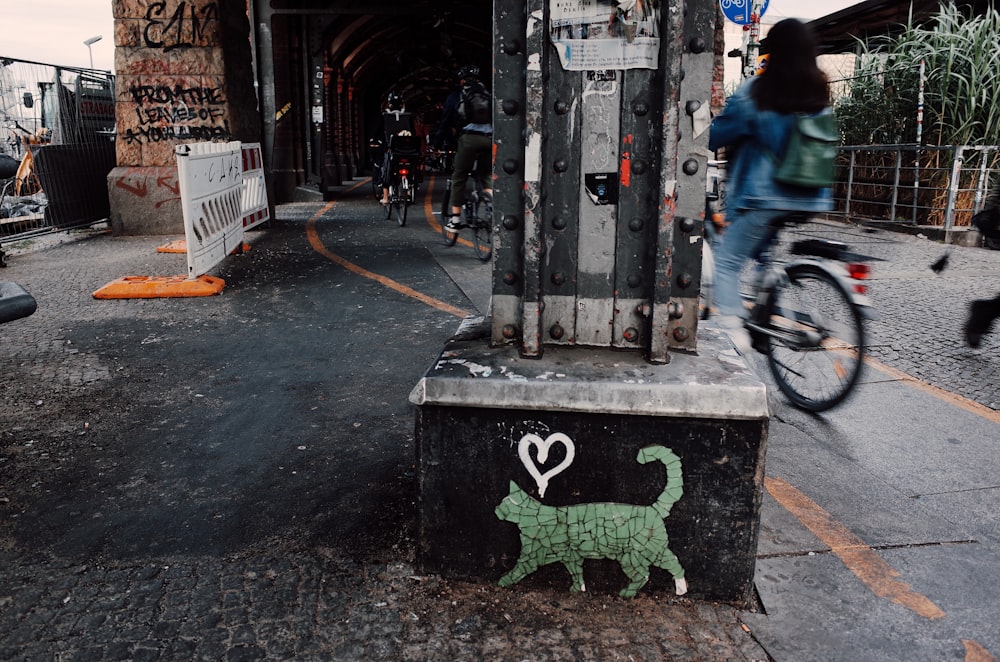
xmin=834 ymin=145 xmax=1000 ymax=231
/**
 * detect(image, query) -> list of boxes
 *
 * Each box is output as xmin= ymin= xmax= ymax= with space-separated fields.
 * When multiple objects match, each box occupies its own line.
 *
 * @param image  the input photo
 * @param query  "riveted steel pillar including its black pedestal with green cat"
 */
xmin=410 ymin=0 xmax=768 ymax=604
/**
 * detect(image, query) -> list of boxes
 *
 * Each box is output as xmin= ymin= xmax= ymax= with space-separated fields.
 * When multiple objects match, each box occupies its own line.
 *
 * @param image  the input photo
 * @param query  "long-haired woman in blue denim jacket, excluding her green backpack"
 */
xmin=708 ymin=19 xmax=833 ymax=354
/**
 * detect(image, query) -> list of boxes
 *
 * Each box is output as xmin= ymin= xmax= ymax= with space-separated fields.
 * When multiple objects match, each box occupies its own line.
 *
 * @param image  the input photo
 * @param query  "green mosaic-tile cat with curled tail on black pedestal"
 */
xmin=494 ymin=444 xmax=687 ymax=598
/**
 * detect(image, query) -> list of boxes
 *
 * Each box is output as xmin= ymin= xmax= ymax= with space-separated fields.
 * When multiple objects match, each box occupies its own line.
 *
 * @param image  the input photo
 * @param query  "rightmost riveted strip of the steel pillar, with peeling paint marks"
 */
xmin=650 ymin=0 xmax=717 ymax=363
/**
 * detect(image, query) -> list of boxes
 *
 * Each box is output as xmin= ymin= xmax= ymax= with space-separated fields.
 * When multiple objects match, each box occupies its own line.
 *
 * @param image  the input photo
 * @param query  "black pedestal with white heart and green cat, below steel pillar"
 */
xmin=410 ymin=328 xmax=768 ymax=604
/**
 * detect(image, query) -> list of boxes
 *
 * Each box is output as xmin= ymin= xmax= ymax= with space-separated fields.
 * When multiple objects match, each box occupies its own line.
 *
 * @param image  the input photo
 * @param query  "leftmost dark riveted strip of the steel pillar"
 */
xmin=492 ymin=0 xmax=540 ymax=345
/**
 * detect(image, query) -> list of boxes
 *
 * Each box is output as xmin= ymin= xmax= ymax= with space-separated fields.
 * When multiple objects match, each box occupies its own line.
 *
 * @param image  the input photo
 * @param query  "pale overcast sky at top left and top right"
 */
xmin=0 ymin=0 xmax=858 ymax=69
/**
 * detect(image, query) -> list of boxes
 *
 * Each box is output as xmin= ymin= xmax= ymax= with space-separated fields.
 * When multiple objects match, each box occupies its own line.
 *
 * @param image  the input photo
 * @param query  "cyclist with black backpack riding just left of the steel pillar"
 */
xmin=431 ymin=65 xmax=493 ymax=232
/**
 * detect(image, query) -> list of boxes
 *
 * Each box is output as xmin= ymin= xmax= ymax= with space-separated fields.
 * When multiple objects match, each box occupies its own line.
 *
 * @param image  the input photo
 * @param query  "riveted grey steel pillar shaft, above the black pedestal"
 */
xmin=492 ymin=0 xmax=717 ymax=363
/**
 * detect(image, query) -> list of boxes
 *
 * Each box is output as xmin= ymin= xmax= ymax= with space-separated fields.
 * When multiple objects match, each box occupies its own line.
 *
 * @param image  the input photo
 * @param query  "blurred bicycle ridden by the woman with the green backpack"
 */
xmin=704 ymin=213 xmax=874 ymax=412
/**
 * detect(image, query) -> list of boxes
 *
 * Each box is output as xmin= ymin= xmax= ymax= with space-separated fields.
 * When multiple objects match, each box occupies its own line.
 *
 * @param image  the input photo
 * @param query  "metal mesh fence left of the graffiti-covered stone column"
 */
xmin=0 ymin=56 xmax=115 ymax=262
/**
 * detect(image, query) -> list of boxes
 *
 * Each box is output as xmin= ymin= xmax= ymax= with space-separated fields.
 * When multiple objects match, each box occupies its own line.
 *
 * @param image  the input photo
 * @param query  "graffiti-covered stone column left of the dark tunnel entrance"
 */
xmin=108 ymin=0 xmax=261 ymax=235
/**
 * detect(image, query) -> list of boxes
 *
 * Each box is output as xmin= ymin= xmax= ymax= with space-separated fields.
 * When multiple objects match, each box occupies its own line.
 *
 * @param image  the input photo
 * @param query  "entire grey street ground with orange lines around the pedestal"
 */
xmin=0 ymin=181 xmax=1000 ymax=662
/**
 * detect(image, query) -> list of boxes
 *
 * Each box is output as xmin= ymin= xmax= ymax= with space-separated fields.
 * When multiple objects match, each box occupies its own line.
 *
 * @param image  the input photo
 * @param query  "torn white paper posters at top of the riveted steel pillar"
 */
xmin=549 ymin=0 xmax=660 ymax=71
